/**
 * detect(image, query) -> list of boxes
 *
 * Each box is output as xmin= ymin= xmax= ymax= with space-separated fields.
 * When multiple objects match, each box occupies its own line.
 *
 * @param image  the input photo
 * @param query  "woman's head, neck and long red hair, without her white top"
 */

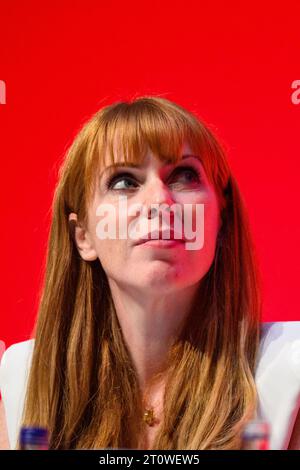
xmin=1 ymin=97 xmax=298 ymax=449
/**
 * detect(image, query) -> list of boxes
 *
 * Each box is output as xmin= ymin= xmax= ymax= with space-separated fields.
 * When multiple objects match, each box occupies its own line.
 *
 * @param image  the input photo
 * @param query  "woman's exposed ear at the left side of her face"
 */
xmin=69 ymin=212 xmax=98 ymax=261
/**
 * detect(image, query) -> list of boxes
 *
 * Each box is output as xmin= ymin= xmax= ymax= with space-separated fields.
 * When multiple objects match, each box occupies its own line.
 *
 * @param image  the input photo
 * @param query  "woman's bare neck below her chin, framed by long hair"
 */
xmin=110 ymin=281 xmax=198 ymax=390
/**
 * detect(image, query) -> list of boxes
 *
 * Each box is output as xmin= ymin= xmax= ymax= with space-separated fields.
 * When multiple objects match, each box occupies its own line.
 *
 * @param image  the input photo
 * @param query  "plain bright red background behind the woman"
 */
xmin=0 ymin=0 xmax=300 ymax=347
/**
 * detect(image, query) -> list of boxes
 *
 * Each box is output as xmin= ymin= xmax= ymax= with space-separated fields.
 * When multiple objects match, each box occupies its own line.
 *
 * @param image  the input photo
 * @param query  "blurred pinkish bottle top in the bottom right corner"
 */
xmin=242 ymin=419 xmax=271 ymax=450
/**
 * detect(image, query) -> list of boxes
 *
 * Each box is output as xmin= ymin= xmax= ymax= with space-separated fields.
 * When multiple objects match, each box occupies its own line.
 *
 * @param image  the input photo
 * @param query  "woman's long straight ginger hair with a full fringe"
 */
xmin=18 ymin=96 xmax=262 ymax=449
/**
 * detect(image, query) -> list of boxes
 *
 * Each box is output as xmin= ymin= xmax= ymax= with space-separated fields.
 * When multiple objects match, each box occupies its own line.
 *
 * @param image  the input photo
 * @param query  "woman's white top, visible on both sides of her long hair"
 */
xmin=0 ymin=321 xmax=300 ymax=450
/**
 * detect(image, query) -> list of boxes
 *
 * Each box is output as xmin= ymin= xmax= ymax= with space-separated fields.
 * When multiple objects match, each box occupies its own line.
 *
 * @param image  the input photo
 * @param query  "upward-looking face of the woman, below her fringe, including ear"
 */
xmin=72 ymin=140 xmax=220 ymax=293
